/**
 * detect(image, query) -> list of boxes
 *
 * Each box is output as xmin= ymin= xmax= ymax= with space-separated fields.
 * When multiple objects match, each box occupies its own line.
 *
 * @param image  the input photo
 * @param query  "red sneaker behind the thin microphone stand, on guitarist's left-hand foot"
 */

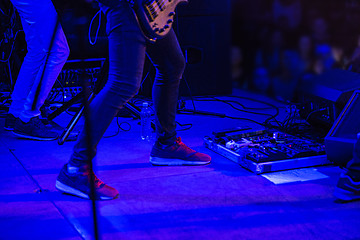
xmin=55 ymin=164 xmax=119 ymax=200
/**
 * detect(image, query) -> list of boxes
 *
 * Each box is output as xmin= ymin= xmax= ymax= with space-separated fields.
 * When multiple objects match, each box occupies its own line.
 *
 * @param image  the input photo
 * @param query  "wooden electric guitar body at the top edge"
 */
xmin=133 ymin=0 xmax=188 ymax=40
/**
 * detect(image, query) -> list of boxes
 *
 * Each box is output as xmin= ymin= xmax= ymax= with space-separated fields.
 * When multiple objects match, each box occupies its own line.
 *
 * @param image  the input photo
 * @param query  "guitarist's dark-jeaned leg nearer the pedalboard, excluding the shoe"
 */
xmin=147 ymin=30 xmax=185 ymax=144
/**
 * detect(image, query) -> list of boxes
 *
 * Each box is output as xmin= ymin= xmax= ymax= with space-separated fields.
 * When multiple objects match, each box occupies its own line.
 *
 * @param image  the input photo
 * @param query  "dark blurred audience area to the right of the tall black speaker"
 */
xmin=231 ymin=0 xmax=360 ymax=101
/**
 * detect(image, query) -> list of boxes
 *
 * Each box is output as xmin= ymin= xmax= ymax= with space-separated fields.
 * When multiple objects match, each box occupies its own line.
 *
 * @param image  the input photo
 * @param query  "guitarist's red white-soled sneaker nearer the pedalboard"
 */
xmin=150 ymin=137 xmax=211 ymax=166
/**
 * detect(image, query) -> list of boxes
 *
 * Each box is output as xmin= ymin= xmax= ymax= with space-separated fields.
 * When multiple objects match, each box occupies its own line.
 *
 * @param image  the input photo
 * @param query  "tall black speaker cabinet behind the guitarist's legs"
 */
xmin=136 ymin=0 xmax=232 ymax=96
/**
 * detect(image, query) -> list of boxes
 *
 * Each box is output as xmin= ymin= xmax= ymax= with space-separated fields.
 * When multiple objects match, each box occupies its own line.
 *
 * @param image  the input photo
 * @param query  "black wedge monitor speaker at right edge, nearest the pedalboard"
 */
xmin=325 ymin=91 xmax=360 ymax=166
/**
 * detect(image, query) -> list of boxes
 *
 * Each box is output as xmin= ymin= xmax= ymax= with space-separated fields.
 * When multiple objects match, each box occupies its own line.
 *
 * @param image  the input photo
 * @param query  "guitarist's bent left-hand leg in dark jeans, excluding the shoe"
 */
xmin=70 ymin=4 xmax=146 ymax=166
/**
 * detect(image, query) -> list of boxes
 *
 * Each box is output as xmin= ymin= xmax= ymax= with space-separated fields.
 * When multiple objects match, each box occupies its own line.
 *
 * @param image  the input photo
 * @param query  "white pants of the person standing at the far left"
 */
xmin=9 ymin=0 xmax=70 ymax=122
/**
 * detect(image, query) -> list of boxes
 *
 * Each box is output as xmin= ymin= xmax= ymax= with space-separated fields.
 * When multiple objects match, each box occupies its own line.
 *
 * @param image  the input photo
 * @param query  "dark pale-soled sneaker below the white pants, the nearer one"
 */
xmin=13 ymin=117 xmax=59 ymax=141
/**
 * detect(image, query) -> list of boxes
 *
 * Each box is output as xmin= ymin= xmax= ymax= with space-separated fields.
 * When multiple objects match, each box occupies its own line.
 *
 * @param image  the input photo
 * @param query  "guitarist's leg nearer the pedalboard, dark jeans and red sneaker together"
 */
xmin=147 ymin=30 xmax=211 ymax=165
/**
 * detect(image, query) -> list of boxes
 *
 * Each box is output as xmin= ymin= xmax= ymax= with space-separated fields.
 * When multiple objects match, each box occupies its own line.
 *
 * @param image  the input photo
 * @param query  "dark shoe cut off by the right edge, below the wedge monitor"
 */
xmin=334 ymin=173 xmax=360 ymax=202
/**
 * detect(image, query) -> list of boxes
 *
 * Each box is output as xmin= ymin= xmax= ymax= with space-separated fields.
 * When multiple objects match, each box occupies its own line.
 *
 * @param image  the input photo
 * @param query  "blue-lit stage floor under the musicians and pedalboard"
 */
xmin=0 ymin=91 xmax=360 ymax=240
